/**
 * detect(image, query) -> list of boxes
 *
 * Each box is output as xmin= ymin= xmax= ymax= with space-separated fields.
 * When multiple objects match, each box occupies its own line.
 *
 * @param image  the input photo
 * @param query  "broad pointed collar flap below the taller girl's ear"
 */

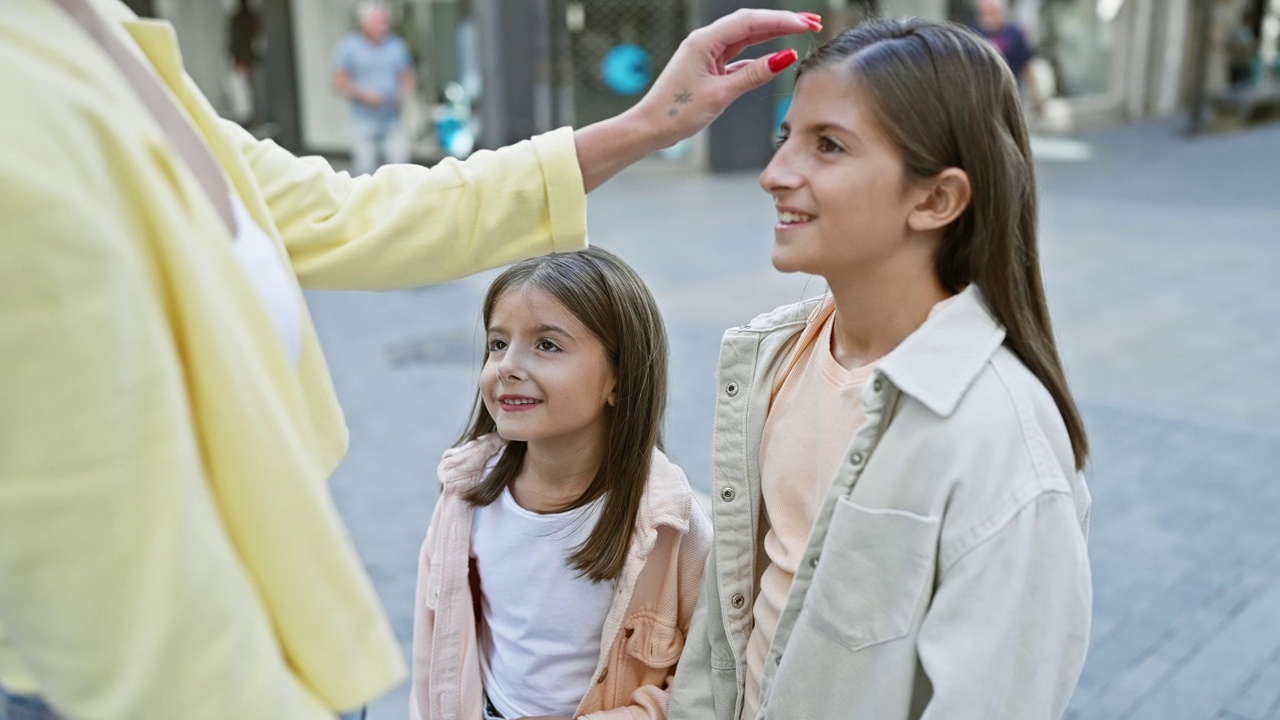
xmin=877 ymin=284 xmax=1005 ymax=416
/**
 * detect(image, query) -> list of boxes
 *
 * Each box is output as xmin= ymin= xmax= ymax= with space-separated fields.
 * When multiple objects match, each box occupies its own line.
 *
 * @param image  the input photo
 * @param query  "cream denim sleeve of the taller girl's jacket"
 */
xmin=918 ymin=491 xmax=1092 ymax=720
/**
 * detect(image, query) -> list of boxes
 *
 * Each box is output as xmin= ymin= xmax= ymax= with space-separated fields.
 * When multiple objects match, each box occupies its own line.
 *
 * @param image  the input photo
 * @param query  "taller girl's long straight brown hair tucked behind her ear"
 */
xmin=796 ymin=18 xmax=1089 ymax=469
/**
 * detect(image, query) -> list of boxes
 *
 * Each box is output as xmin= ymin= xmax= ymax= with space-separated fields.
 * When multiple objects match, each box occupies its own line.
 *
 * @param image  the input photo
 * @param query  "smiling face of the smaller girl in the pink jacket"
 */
xmin=480 ymin=287 xmax=617 ymax=447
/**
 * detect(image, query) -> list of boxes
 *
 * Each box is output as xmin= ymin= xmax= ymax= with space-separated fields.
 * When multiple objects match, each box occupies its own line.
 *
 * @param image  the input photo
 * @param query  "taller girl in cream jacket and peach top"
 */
xmin=671 ymin=19 xmax=1091 ymax=720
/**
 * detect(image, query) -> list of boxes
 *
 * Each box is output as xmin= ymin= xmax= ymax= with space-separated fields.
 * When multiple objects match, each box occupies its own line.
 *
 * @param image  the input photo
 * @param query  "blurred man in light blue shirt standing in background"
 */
xmin=333 ymin=1 xmax=413 ymax=176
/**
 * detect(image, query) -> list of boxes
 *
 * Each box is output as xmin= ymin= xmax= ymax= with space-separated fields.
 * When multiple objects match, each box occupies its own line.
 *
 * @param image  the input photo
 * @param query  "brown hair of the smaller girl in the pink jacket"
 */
xmin=458 ymin=247 xmax=667 ymax=582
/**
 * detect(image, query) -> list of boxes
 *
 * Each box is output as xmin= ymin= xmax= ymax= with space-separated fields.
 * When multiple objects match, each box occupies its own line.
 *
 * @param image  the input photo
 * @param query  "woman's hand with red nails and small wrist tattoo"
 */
xmin=575 ymin=10 xmax=822 ymax=192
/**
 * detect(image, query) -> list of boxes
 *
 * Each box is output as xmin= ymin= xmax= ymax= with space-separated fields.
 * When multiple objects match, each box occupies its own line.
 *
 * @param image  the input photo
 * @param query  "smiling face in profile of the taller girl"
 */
xmin=760 ymin=67 xmax=919 ymax=281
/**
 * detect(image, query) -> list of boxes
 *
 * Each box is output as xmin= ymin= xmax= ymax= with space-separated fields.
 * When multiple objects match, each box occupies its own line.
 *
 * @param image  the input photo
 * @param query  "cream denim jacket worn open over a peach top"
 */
xmin=671 ymin=288 xmax=1092 ymax=720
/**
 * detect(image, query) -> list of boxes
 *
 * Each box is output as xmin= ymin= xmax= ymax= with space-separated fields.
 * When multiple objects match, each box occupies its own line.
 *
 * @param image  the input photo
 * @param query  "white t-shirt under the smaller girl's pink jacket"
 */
xmin=471 ymin=474 xmax=613 ymax=717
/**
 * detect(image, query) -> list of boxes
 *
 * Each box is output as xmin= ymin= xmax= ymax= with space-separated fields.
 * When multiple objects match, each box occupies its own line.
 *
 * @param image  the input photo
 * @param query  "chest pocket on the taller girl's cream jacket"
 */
xmin=805 ymin=497 xmax=940 ymax=651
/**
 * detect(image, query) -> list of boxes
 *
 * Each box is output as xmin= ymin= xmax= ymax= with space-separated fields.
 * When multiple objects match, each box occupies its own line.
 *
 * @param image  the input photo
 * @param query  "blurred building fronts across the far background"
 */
xmin=135 ymin=0 xmax=1280 ymax=163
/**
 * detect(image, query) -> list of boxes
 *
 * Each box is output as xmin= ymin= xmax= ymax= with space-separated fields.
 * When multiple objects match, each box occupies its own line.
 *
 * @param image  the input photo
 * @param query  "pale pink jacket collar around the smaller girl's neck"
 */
xmin=436 ymin=433 xmax=692 ymax=542
